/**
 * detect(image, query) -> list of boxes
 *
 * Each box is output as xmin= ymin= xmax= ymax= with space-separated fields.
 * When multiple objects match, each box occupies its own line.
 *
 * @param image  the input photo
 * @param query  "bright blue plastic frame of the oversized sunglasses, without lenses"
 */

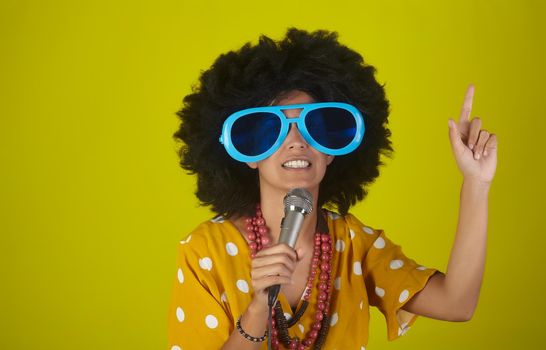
xmin=219 ymin=102 xmax=366 ymax=162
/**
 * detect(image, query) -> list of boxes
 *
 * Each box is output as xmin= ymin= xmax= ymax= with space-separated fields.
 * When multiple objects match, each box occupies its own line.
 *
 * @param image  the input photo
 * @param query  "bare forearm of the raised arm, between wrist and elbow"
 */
xmin=444 ymin=179 xmax=491 ymax=319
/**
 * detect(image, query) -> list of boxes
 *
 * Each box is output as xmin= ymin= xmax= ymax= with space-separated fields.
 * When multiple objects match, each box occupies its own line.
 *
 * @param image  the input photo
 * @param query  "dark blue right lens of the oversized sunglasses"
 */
xmin=305 ymin=107 xmax=356 ymax=149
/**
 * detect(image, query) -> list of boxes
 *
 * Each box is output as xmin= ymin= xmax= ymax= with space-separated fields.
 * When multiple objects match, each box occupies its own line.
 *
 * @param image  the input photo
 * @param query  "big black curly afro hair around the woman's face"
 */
xmin=173 ymin=28 xmax=393 ymax=216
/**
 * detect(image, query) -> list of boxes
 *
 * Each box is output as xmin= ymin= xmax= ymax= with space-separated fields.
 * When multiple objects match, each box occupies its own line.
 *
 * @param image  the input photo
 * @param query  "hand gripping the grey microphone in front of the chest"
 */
xmin=250 ymin=243 xmax=297 ymax=310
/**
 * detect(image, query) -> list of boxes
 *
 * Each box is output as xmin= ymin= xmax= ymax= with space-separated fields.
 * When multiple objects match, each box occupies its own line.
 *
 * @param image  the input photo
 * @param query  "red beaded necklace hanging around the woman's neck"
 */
xmin=245 ymin=205 xmax=333 ymax=350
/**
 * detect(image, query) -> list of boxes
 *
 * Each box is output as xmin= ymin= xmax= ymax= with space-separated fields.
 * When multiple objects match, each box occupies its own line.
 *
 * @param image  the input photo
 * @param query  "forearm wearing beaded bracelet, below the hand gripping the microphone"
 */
xmin=222 ymin=303 xmax=268 ymax=350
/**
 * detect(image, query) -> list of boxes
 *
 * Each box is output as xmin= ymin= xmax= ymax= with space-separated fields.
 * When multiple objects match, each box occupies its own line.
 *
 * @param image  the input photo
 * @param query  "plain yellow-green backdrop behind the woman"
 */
xmin=0 ymin=0 xmax=546 ymax=350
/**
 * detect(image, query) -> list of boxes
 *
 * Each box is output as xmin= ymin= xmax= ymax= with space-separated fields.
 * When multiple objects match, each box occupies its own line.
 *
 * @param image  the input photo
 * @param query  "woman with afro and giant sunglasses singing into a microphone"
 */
xmin=169 ymin=28 xmax=497 ymax=350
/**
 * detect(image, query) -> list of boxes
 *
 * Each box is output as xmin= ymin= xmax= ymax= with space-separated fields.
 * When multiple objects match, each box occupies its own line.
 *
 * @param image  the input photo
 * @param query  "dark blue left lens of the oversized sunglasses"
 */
xmin=231 ymin=112 xmax=281 ymax=157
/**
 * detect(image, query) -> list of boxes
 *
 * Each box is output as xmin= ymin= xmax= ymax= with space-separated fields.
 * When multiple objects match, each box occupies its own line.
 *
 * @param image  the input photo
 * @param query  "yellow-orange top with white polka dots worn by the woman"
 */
xmin=168 ymin=211 xmax=437 ymax=350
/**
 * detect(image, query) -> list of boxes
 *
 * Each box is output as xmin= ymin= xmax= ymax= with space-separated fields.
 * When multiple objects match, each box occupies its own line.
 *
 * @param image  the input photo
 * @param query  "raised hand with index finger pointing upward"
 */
xmin=449 ymin=85 xmax=497 ymax=184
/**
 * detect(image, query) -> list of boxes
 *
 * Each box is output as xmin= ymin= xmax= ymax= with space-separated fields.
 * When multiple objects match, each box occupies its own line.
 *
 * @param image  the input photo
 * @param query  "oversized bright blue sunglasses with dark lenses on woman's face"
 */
xmin=220 ymin=102 xmax=365 ymax=162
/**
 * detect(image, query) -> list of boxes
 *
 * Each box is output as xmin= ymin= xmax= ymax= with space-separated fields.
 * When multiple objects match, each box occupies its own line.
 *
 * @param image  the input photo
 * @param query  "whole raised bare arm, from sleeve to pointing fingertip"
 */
xmin=403 ymin=85 xmax=497 ymax=321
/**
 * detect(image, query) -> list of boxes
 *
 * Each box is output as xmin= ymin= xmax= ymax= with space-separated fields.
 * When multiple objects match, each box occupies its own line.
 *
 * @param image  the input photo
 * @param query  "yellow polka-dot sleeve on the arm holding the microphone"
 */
xmin=168 ymin=236 xmax=233 ymax=350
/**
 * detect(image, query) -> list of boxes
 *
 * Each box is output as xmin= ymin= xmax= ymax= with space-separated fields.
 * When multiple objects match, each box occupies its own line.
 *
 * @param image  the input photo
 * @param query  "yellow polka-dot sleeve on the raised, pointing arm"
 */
xmin=346 ymin=217 xmax=438 ymax=340
